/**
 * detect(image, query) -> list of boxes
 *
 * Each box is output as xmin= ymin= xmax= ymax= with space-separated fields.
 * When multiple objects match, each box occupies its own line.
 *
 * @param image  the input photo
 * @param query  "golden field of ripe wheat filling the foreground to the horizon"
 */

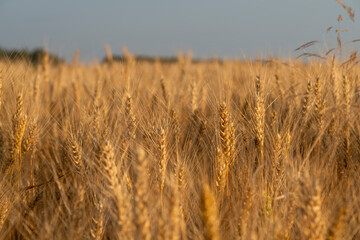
xmin=0 ymin=49 xmax=360 ymax=240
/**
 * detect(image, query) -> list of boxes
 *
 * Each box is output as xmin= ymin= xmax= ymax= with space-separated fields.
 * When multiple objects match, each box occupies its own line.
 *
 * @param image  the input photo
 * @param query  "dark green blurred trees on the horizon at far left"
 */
xmin=0 ymin=47 xmax=64 ymax=65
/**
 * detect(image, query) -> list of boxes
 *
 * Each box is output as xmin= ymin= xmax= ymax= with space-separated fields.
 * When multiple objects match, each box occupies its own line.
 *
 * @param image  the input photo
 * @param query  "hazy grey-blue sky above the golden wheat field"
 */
xmin=0 ymin=0 xmax=360 ymax=62
